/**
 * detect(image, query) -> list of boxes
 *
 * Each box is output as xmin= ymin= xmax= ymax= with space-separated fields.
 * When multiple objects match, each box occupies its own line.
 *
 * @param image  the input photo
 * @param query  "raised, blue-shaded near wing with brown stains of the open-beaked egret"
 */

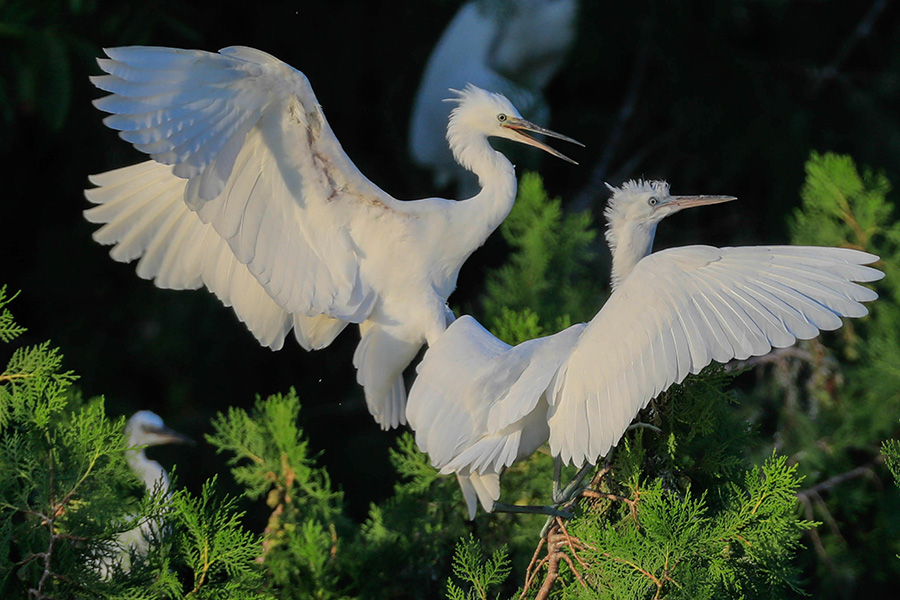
xmin=88 ymin=47 xmax=402 ymax=326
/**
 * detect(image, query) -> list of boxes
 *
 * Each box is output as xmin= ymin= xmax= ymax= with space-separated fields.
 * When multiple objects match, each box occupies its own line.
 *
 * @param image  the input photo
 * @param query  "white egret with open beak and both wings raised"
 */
xmin=85 ymin=46 xmax=577 ymax=429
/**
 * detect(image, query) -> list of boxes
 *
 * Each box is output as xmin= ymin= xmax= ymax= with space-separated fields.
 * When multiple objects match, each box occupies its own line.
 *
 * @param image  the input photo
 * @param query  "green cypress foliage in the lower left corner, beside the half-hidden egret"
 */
xmin=0 ymin=290 xmax=265 ymax=600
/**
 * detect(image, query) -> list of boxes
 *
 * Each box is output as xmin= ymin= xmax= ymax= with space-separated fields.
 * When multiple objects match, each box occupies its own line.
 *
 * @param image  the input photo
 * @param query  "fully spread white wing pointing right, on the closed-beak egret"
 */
xmin=549 ymin=246 xmax=883 ymax=465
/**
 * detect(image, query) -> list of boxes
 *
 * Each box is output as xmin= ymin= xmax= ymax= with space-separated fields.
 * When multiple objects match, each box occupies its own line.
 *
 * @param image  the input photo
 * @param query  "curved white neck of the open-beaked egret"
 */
xmin=447 ymin=129 xmax=516 ymax=253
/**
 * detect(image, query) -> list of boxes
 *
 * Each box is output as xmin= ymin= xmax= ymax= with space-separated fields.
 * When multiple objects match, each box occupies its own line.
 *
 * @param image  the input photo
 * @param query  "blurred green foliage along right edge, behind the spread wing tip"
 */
xmin=744 ymin=152 xmax=900 ymax=598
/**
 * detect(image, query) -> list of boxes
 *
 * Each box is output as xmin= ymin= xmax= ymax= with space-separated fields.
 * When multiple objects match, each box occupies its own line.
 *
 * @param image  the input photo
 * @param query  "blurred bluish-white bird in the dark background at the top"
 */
xmin=408 ymin=0 xmax=577 ymax=192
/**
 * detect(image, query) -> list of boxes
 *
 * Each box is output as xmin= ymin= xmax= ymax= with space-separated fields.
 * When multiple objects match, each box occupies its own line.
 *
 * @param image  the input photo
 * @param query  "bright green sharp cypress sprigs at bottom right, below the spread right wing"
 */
xmin=564 ymin=456 xmax=810 ymax=599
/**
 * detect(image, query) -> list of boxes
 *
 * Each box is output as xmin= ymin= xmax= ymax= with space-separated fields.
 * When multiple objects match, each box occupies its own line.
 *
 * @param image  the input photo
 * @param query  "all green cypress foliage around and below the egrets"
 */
xmin=0 ymin=154 xmax=900 ymax=600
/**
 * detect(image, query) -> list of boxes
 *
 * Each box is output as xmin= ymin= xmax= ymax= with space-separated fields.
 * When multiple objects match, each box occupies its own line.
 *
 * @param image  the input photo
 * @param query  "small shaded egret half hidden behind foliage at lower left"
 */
xmin=96 ymin=410 xmax=193 ymax=579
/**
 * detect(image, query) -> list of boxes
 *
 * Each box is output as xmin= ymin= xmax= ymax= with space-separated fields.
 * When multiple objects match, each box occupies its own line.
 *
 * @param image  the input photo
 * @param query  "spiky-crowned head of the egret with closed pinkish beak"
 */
xmin=604 ymin=179 xmax=736 ymax=228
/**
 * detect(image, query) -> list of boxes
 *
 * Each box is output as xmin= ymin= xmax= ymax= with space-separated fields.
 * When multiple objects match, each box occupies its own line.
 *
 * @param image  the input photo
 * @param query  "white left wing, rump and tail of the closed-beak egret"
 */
xmin=406 ymin=315 xmax=585 ymax=517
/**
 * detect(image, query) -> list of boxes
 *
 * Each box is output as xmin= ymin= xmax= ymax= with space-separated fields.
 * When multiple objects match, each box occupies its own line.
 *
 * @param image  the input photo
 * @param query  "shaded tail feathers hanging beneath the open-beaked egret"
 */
xmin=353 ymin=321 xmax=422 ymax=430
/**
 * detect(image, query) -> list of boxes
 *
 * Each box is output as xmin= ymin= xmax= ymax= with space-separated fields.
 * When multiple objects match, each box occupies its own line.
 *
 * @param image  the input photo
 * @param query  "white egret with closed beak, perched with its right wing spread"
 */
xmin=407 ymin=181 xmax=884 ymax=517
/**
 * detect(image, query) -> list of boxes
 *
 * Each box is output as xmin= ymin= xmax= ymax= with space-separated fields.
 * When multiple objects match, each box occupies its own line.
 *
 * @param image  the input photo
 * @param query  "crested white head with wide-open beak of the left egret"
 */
xmin=447 ymin=83 xmax=584 ymax=164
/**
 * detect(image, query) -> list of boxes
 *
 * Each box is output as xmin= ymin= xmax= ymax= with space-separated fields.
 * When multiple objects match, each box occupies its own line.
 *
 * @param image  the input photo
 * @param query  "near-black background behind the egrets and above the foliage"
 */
xmin=0 ymin=0 xmax=900 ymax=519
